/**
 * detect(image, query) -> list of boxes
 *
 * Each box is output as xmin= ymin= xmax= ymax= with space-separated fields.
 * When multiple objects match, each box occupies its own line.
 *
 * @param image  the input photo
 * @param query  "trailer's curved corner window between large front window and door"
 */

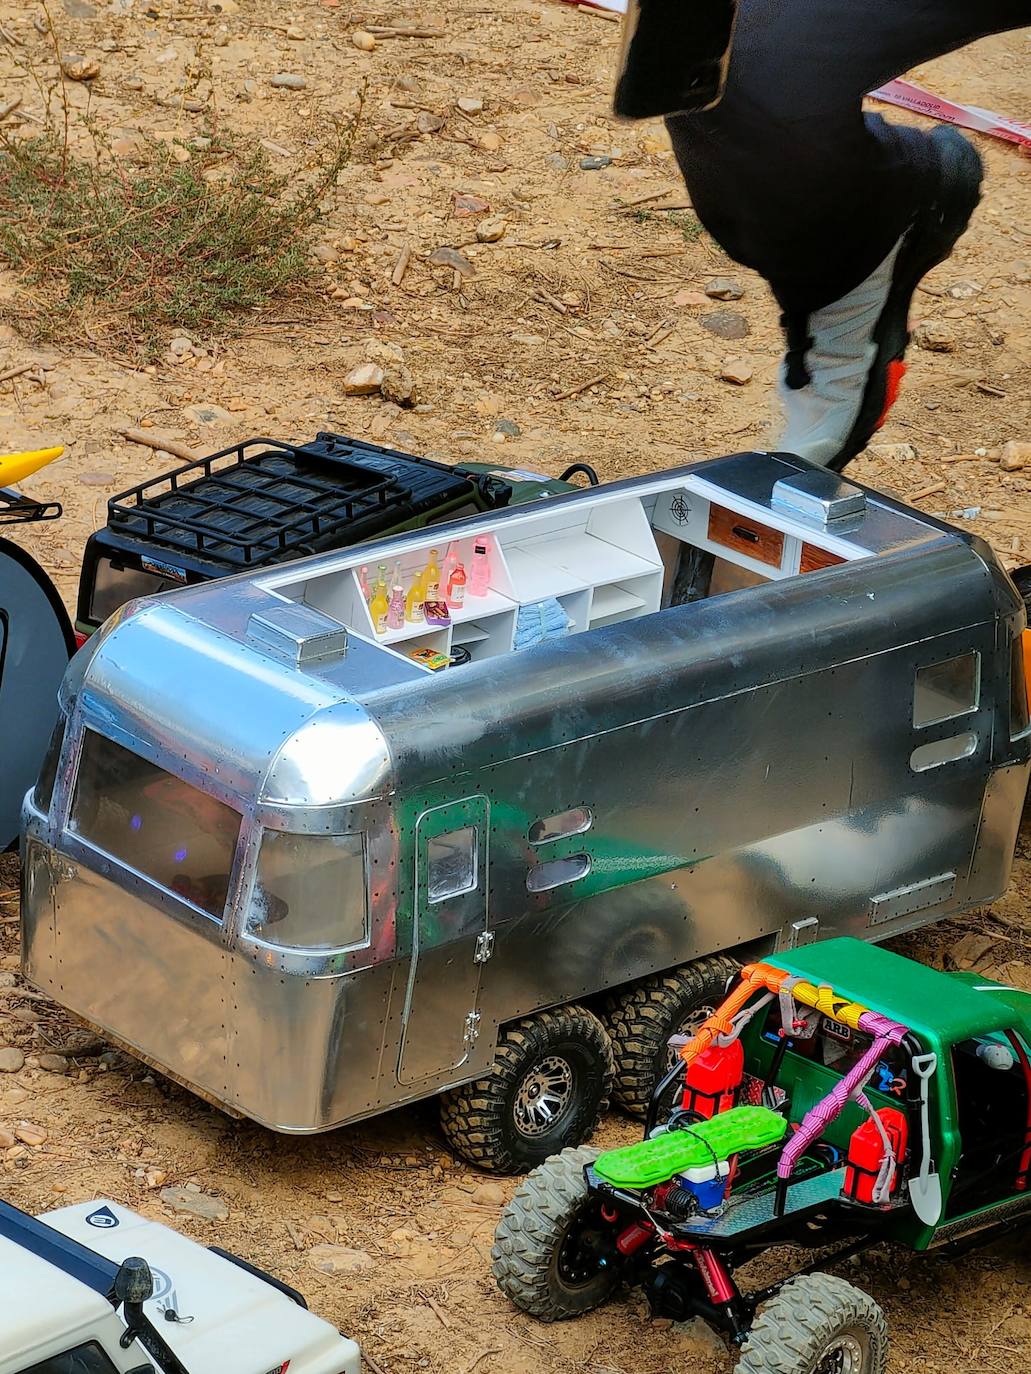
xmin=247 ymin=830 xmax=368 ymax=949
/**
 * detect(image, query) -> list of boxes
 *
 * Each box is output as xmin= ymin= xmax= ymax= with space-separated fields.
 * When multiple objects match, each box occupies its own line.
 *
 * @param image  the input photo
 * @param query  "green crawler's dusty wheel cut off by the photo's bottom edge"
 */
xmin=734 ymin=1274 xmax=888 ymax=1374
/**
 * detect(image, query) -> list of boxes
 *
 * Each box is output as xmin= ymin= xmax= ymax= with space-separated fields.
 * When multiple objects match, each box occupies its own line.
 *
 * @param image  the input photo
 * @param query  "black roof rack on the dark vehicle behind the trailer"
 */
xmin=107 ymin=434 xmax=418 ymax=569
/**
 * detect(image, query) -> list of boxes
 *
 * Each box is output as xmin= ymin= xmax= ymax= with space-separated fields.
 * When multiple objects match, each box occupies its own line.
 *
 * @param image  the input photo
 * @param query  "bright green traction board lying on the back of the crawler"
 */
xmin=594 ymin=1107 xmax=788 ymax=1189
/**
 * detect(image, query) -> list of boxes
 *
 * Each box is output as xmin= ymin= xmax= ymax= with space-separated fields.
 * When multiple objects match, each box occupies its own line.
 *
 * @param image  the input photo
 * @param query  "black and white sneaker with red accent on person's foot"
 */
xmin=777 ymin=126 xmax=983 ymax=473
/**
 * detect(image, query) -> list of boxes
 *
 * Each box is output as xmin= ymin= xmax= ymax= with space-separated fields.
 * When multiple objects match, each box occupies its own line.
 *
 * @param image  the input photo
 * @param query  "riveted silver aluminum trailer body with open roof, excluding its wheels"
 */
xmin=23 ymin=455 xmax=1028 ymax=1154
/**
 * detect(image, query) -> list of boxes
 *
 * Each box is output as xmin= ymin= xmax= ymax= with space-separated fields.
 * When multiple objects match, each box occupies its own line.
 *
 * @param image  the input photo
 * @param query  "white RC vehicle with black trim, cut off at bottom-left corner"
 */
xmin=0 ymin=1201 xmax=362 ymax=1374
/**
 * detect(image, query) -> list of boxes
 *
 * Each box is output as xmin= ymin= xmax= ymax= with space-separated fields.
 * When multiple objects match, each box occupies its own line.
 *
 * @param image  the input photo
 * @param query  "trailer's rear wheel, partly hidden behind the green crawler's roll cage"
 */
xmin=605 ymin=954 xmax=741 ymax=1117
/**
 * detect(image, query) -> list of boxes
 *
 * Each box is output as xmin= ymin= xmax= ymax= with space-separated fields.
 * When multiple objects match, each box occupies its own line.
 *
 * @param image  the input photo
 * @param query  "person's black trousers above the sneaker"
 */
xmin=667 ymin=0 xmax=1031 ymax=312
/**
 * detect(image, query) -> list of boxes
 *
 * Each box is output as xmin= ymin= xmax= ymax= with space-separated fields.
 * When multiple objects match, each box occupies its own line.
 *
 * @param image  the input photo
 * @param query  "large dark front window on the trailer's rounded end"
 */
xmin=71 ymin=730 xmax=241 ymax=918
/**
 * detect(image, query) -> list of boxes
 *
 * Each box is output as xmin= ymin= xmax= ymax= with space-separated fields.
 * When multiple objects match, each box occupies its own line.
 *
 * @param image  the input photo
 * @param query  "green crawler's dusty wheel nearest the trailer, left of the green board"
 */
xmin=491 ymin=1146 xmax=620 ymax=1322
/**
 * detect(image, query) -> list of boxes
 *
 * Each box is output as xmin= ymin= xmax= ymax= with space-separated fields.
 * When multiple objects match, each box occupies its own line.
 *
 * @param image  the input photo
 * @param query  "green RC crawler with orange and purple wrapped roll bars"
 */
xmin=494 ymin=940 xmax=1031 ymax=1374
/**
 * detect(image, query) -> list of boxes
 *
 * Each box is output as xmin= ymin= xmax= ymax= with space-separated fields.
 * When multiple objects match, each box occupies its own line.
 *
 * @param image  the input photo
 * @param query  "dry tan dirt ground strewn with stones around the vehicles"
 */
xmin=0 ymin=0 xmax=1031 ymax=1374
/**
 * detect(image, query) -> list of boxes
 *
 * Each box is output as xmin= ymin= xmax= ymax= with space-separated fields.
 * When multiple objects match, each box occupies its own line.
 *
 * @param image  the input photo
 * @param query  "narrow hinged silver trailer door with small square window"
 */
xmin=397 ymin=797 xmax=489 ymax=1083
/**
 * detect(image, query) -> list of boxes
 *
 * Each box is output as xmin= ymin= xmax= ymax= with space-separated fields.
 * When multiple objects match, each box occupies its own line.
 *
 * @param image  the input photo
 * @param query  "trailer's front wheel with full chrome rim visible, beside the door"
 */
xmin=440 ymin=1006 xmax=613 ymax=1173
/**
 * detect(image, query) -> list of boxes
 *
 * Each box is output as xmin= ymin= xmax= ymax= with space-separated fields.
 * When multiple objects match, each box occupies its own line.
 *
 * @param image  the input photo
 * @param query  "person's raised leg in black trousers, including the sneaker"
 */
xmin=667 ymin=0 xmax=1031 ymax=467
